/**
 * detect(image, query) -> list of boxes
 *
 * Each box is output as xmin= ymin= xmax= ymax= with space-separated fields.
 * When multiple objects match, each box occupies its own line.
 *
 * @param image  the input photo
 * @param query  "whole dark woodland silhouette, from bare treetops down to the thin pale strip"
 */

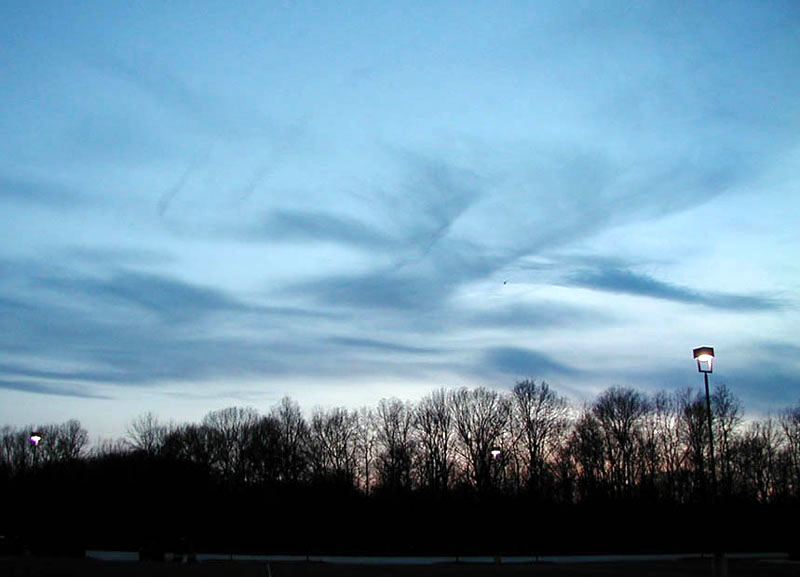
xmin=0 ymin=381 xmax=800 ymax=557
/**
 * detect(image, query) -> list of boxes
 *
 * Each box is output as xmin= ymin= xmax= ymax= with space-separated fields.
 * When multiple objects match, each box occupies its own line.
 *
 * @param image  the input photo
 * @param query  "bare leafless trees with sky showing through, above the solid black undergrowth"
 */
xmin=6 ymin=380 xmax=800 ymax=503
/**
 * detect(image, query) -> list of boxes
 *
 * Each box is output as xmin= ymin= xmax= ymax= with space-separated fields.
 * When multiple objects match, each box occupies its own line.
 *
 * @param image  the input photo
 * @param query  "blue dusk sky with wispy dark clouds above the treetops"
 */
xmin=0 ymin=0 xmax=800 ymax=439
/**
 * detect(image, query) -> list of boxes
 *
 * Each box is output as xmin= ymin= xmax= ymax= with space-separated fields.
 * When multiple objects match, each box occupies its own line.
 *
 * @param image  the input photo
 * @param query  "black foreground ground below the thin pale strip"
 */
xmin=0 ymin=557 xmax=800 ymax=577
